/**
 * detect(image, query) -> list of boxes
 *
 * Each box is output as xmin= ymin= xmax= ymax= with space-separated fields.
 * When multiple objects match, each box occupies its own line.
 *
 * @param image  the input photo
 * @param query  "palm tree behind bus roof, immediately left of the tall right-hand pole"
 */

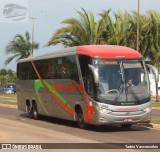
xmin=99 ymin=10 xmax=137 ymax=48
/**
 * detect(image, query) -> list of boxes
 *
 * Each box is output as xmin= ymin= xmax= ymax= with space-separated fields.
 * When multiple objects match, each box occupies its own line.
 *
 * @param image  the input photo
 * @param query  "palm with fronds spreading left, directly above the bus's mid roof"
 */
xmin=48 ymin=9 xmax=103 ymax=47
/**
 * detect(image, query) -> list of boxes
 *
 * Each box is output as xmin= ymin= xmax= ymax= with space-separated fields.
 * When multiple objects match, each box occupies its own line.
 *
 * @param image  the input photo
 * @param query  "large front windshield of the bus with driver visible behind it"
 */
xmin=95 ymin=59 xmax=150 ymax=105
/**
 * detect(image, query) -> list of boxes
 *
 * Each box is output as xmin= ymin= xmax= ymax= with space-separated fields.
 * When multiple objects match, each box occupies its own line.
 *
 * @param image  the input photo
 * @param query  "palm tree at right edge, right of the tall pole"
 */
xmin=140 ymin=10 xmax=160 ymax=67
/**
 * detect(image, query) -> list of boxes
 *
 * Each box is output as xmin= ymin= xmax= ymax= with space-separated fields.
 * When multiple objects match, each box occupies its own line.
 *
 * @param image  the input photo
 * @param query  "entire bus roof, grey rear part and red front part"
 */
xmin=18 ymin=45 xmax=142 ymax=62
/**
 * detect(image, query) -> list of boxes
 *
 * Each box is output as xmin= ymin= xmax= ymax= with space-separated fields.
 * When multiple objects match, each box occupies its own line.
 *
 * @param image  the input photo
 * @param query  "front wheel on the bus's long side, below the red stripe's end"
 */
xmin=76 ymin=108 xmax=86 ymax=129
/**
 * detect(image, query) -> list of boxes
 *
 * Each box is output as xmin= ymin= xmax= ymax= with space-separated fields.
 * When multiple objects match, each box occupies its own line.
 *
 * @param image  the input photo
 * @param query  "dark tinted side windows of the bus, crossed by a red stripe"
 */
xmin=17 ymin=56 xmax=79 ymax=82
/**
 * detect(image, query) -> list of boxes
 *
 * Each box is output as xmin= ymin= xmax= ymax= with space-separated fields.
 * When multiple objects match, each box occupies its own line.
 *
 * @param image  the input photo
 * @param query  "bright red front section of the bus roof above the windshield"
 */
xmin=77 ymin=45 xmax=142 ymax=59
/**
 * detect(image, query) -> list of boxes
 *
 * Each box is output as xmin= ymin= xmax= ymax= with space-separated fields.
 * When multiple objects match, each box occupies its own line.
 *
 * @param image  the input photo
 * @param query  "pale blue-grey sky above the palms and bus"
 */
xmin=0 ymin=0 xmax=160 ymax=71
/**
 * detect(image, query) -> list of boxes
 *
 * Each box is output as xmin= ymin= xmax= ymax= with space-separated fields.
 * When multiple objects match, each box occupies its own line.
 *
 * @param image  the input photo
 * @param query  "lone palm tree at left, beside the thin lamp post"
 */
xmin=5 ymin=32 xmax=39 ymax=65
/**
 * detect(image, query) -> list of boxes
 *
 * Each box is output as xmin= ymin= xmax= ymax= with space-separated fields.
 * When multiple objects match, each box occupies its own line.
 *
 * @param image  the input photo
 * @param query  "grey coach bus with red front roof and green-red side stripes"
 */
xmin=16 ymin=45 xmax=158 ymax=128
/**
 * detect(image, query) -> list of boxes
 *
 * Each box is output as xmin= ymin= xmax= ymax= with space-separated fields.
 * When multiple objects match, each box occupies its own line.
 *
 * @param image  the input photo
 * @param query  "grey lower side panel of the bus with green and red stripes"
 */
xmin=17 ymin=79 xmax=85 ymax=120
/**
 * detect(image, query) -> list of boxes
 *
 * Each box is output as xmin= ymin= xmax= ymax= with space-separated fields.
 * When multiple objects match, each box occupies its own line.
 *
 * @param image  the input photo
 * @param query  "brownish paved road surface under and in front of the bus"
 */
xmin=0 ymin=107 xmax=160 ymax=151
